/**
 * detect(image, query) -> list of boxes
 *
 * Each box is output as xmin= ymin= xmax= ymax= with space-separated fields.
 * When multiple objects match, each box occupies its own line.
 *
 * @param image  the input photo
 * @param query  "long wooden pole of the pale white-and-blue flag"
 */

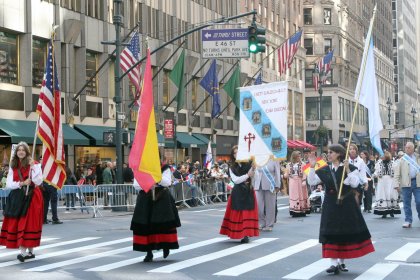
xmin=337 ymin=4 xmax=377 ymax=204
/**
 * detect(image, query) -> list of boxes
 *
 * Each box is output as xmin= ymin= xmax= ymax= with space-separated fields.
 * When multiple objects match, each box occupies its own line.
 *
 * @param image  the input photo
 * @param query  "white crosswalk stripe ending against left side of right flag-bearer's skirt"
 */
xmin=214 ymin=239 xmax=319 ymax=276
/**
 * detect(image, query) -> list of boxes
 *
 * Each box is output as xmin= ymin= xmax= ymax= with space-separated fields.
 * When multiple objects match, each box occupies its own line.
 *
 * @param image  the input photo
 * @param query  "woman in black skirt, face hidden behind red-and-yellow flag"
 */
xmin=130 ymin=164 xmax=181 ymax=262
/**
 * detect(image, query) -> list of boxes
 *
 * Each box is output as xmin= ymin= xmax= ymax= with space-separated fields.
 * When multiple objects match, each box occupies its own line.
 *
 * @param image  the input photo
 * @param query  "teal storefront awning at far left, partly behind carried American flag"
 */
xmin=0 ymin=120 xmax=89 ymax=146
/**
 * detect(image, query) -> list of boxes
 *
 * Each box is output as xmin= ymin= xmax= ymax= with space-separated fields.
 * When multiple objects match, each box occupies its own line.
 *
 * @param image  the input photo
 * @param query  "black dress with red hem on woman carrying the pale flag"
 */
xmin=310 ymin=165 xmax=375 ymax=259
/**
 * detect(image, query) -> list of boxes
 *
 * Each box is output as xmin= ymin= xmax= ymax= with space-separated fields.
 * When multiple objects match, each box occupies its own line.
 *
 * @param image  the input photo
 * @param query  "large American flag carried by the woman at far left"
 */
xmin=36 ymin=42 xmax=66 ymax=189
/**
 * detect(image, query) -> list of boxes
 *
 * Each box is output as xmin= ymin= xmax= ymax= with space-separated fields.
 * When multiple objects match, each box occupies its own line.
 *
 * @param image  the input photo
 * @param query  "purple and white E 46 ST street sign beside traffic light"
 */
xmin=201 ymin=28 xmax=249 ymax=58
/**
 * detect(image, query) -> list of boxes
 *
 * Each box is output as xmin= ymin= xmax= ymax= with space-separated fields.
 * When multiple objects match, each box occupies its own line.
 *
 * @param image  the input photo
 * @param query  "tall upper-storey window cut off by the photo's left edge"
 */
xmin=0 ymin=31 xmax=19 ymax=85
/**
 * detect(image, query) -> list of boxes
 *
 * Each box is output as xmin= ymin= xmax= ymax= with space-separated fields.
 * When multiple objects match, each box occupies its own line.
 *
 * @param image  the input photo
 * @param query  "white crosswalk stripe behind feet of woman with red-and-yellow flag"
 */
xmin=86 ymin=237 xmax=228 ymax=271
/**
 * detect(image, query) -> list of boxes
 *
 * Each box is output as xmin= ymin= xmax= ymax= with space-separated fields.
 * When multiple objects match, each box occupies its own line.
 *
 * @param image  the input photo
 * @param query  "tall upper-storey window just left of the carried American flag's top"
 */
xmin=32 ymin=39 xmax=48 ymax=88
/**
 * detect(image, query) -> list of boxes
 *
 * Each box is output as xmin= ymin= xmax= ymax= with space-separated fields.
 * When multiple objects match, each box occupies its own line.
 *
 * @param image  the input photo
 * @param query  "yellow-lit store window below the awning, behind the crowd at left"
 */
xmin=74 ymin=147 xmax=116 ymax=169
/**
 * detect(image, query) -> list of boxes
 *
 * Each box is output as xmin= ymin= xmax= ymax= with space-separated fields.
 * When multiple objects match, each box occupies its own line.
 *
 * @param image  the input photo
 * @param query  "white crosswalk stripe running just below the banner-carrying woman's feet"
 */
xmin=148 ymin=238 xmax=278 ymax=273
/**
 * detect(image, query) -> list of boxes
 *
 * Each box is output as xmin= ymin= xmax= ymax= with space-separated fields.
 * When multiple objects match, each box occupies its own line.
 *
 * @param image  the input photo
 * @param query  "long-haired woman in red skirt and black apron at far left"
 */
xmin=0 ymin=142 xmax=44 ymax=262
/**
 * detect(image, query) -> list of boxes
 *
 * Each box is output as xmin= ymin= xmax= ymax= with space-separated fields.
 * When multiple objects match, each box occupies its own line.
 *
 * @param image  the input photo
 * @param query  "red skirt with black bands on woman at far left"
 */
xmin=0 ymin=188 xmax=44 ymax=248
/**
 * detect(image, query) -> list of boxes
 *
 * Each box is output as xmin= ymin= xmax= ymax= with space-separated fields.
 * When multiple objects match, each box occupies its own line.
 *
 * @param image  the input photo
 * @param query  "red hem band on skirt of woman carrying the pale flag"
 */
xmin=322 ymin=239 xmax=375 ymax=259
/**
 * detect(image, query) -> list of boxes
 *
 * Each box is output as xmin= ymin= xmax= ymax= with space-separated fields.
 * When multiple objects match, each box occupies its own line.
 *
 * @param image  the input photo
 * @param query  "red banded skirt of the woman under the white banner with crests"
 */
xmin=220 ymin=192 xmax=260 ymax=239
